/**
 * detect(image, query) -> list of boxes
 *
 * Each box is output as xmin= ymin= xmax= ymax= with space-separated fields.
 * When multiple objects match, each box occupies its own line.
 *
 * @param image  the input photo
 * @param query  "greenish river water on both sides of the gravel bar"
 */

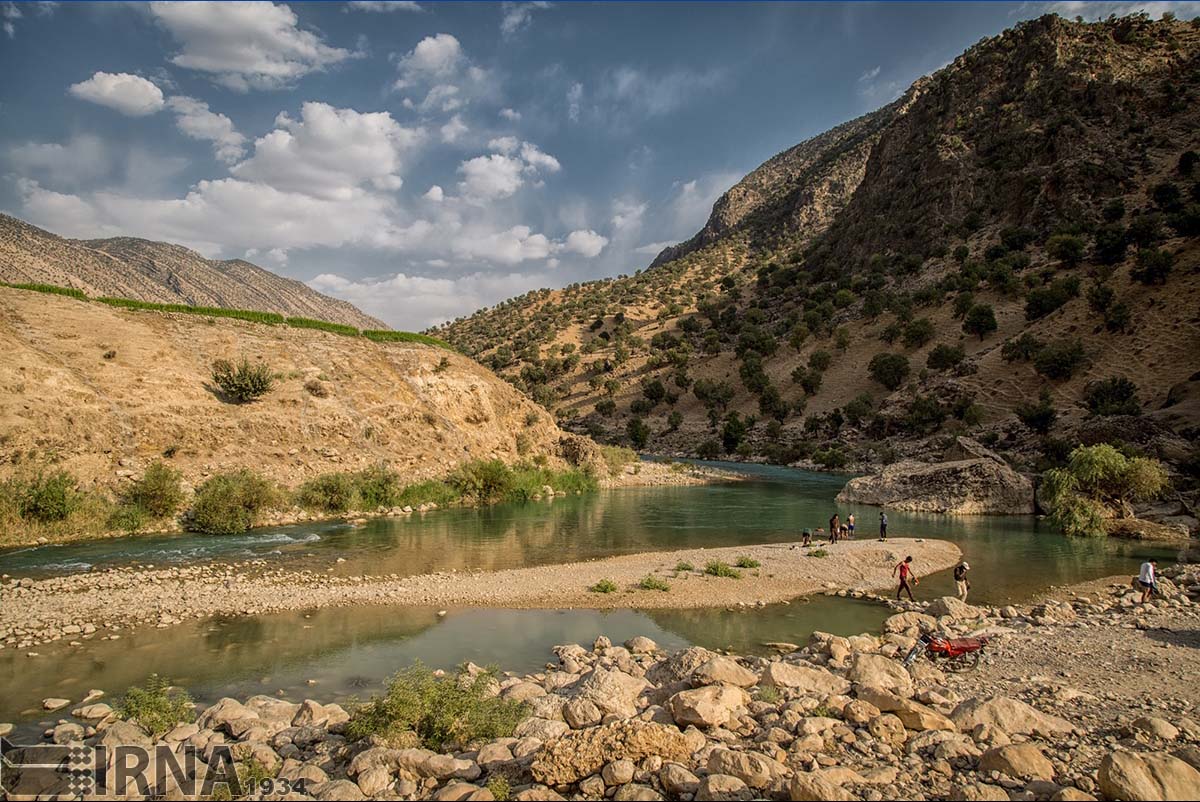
xmin=0 ymin=463 xmax=1170 ymax=732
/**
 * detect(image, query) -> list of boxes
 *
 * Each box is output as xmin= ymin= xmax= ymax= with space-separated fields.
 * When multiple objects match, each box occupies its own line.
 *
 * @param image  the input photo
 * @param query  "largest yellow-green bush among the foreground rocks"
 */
xmin=346 ymin=663 xmax=528 ymax=752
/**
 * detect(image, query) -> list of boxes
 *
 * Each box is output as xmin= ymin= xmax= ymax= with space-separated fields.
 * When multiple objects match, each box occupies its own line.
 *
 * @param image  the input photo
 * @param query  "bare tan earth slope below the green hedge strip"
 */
xmin=0 ymin=287 xmax=562 ymax=486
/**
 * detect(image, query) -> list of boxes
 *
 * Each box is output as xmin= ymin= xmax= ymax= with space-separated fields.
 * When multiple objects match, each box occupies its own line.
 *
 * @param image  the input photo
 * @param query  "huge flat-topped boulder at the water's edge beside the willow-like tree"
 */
xmin=838 ymin=457 xmax=1034 ymax=515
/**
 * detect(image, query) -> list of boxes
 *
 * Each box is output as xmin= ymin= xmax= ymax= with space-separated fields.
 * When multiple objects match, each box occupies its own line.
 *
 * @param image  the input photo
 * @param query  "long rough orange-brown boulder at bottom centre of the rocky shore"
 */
xmin=529 ymin=719 xmax=691 ymax=785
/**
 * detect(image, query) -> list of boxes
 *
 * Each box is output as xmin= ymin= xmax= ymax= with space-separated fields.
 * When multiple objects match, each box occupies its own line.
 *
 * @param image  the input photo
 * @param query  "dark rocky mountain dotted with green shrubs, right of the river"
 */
xmin=433 ymin=16 xmax=1200 ymax=472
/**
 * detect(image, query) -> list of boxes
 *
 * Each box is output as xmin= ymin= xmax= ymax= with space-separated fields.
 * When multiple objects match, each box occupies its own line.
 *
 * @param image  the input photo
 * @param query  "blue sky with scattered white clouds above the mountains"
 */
xmin=0 ymin=1 xmax=1200 ymax=329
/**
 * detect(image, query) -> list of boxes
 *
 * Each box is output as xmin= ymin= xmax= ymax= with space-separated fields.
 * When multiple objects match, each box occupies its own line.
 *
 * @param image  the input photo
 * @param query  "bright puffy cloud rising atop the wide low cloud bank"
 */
xmin=230 ymin=102 xmax=422 ymax=201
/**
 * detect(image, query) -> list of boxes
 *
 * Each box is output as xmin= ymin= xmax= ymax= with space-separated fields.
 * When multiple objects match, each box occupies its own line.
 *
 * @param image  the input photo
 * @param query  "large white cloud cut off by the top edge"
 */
xmin=150 ymin=0 xmax=352 ymax=91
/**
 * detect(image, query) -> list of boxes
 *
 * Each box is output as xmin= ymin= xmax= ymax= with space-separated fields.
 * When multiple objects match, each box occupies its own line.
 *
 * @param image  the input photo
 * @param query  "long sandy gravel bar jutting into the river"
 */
xmin=0 ymin=539 xmax=959 ymax=648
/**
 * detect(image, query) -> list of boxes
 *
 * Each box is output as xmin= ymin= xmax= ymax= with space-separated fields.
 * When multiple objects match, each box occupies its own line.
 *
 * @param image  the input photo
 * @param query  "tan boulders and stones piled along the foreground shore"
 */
xmin=9 ymin=582 xmax=1200 ymax=801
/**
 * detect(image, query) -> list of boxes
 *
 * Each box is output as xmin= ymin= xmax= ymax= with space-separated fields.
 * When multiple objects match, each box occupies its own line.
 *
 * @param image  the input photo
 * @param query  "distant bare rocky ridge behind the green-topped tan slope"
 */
xmin=0 ymin=215 xmax=388 ymax=329
